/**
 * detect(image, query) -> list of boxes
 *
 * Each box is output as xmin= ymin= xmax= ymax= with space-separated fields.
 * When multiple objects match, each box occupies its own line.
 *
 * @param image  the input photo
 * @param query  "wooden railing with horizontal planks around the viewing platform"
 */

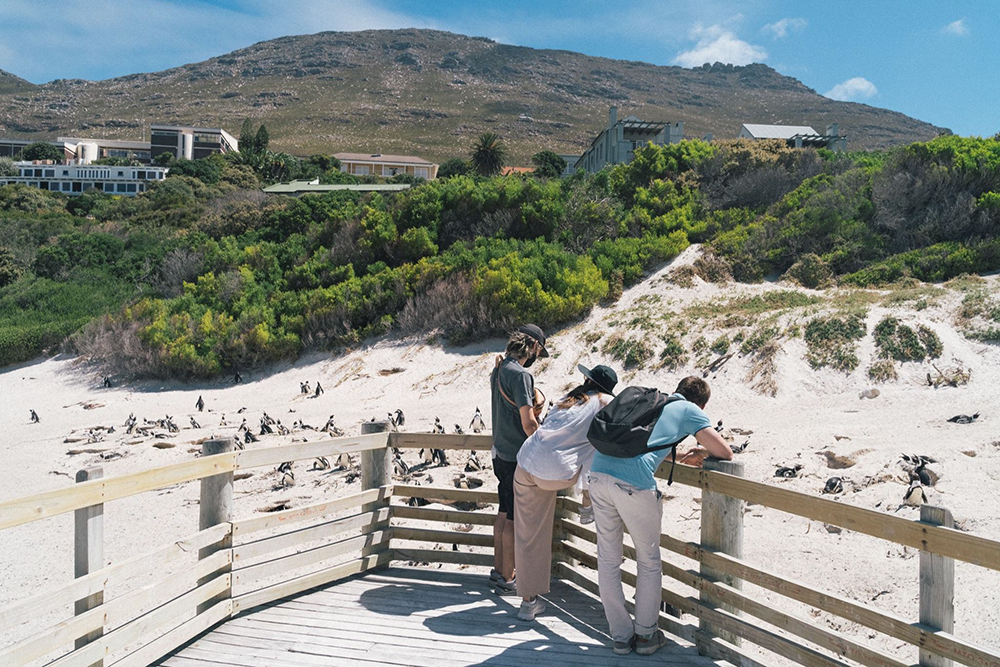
xmin=0 ymin=423 xmax=1000 ymax=667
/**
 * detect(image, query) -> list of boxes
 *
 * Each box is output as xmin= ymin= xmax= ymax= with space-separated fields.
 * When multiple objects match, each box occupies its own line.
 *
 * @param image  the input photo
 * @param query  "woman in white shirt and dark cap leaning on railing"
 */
xmin=514 ymin=366 xmax=618 ymax=621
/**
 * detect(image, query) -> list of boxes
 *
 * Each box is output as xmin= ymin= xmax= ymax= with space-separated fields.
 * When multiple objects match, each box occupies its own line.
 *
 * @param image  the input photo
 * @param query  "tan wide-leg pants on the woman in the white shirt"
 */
xmin=514 ymin=466 xmax=580 ymax=598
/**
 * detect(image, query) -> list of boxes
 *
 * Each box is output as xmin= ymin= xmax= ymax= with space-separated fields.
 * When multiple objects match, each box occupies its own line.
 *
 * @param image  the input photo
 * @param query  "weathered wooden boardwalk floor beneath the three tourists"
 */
xmin=160 ymin=567 xmax=717 ymax=667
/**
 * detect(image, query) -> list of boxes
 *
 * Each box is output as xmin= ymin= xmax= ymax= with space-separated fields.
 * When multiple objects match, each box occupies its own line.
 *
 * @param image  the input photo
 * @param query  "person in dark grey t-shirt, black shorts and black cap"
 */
xmin=490 ymin=324 xmax=549 ymax=595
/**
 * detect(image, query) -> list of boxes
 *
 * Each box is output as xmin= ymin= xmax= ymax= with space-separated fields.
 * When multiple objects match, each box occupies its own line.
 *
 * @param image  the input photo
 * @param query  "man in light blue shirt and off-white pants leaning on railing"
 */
xmin=590 ymin=375 xmax=733 ymax=655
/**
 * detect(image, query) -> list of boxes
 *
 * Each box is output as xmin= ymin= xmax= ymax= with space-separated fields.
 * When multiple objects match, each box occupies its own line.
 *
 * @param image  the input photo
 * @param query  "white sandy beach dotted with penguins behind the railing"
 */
xmin=0 ymin=247 xmax=1000 ymax=660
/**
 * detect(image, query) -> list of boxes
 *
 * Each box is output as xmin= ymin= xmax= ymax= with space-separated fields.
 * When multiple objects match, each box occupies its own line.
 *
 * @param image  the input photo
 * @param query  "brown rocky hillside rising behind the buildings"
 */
xmin=0 ymin=29 xmax=942 ymax=163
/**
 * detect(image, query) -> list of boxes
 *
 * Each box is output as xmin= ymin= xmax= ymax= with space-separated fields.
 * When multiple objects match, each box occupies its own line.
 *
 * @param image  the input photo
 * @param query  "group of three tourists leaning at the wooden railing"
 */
xmin=490 ymin=324 xmax=733 ymax=655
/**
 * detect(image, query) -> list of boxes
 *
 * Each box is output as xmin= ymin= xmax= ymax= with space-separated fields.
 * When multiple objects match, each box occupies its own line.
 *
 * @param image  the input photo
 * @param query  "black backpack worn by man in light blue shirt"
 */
xmin=587 ymin=387 xmax=687 ymax=485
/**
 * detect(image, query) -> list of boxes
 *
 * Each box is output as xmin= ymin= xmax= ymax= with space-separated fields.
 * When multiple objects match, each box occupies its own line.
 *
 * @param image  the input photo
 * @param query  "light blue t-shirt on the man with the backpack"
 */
xmin=590 ymin=394 xmax=712 ymax=489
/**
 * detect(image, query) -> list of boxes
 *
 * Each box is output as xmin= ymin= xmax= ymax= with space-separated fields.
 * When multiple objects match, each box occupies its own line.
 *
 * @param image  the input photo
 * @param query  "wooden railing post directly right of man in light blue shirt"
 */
xmin=698 ymin=459 xmax=745 ymax=655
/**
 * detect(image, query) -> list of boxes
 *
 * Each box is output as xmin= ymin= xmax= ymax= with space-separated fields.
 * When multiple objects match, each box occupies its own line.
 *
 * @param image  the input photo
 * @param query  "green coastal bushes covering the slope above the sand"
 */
xmin=0 ymin=133 xmax=1000 ymax=383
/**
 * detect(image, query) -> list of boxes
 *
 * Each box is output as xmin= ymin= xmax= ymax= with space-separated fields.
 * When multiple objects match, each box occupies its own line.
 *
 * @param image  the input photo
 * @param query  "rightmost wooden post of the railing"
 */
xmin=920 ymin=505 xmax=955 ymax=667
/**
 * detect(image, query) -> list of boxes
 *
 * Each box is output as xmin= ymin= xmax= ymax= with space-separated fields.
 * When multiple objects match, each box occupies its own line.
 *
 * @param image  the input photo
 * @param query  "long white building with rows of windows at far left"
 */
xmin=0 ymin=162 xmax=167 ymax=197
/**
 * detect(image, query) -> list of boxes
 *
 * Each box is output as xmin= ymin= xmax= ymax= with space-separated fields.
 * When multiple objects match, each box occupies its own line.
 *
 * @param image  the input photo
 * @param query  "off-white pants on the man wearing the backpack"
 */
xmin=590 ymin=472 xmax=663 ymax=642
